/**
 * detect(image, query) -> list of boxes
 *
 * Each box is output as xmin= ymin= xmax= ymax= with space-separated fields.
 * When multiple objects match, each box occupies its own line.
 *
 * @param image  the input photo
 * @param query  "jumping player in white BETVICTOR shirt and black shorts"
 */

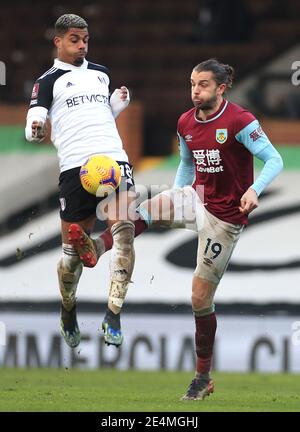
xmin=25 ymin=14 xmax=135 ymax=348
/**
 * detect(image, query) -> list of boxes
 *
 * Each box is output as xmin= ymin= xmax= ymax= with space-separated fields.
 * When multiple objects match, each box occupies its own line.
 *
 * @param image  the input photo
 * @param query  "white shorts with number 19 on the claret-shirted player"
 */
xmin=162 ymin=186 xmax=244 ymax=285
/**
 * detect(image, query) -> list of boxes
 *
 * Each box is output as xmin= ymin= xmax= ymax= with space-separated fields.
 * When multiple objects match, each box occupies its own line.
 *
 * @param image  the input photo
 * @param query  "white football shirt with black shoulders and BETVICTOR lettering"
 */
xmin=27 ymin=59 xmax=128 ymax=172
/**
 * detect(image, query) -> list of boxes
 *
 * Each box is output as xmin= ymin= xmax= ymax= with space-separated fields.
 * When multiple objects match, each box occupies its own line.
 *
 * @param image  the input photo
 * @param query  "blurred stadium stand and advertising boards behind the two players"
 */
xmin=0 ymin=0 xmax=300 ymax=372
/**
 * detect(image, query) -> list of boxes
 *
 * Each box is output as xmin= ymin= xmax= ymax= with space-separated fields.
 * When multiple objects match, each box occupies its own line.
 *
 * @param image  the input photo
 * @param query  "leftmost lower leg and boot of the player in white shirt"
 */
xmin=57 ymin=216 xmax=95 ymax=348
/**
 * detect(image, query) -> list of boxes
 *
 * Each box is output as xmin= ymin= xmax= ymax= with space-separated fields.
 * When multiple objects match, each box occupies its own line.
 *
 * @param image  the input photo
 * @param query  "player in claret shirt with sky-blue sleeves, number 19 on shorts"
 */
xmin=71 ymin=59 xmax=283 ymax=400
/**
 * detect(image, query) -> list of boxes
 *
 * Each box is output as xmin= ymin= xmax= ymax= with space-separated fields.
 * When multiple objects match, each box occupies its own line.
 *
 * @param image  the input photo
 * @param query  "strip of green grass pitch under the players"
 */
xmin=0 ymin=368 xmax=300 ymax=412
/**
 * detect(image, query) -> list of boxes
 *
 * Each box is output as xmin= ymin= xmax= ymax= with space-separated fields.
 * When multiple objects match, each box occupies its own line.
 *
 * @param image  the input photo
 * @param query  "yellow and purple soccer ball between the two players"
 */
xmin=79 ymin=155 xmax=121 ymax=197
